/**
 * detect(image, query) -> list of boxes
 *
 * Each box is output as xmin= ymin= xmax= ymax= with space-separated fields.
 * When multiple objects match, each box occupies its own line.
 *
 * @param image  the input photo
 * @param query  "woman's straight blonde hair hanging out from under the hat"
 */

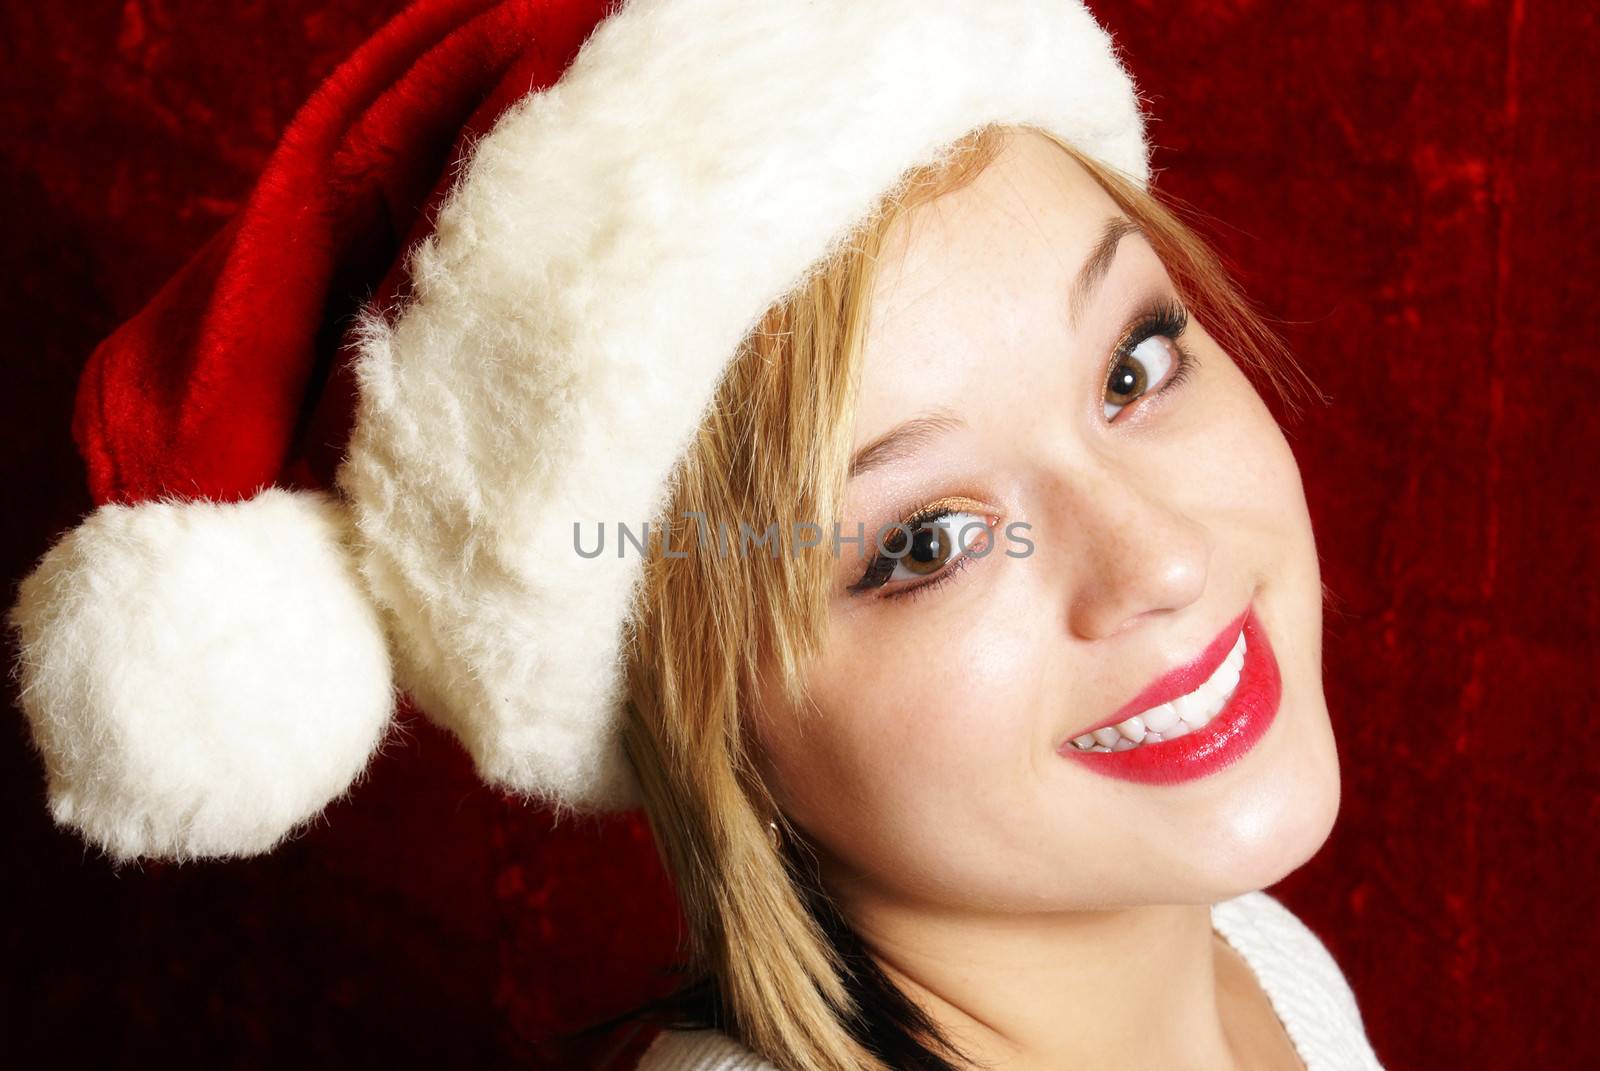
xmin=624 ymin=125 xmax=1309 ymax=1071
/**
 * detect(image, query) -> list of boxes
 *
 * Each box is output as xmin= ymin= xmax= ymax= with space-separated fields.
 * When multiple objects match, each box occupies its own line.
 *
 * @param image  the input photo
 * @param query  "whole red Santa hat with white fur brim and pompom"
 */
xmin=8 ymin=0 xmax=1147 ymax=858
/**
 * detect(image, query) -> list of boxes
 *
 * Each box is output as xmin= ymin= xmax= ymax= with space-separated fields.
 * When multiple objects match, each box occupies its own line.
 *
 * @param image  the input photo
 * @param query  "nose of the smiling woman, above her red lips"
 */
xmin=1058 ymin=461 xmax=1213 ymax=640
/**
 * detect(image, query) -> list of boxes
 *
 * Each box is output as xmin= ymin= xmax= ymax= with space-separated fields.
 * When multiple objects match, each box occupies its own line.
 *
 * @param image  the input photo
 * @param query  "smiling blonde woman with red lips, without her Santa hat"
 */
xmin=629 ymin=126 xmax=1376 ymax=1068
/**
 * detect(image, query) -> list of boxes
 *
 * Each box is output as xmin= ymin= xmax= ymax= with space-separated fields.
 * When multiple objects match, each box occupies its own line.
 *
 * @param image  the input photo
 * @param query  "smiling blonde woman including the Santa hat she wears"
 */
xmin=11 ymin=0 xmax=1376 ymax=1071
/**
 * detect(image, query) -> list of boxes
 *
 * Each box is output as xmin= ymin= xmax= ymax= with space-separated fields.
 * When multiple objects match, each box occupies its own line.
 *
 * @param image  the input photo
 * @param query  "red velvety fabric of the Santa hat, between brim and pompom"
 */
xmin=74 ymin=0 xmax=610 ymax=504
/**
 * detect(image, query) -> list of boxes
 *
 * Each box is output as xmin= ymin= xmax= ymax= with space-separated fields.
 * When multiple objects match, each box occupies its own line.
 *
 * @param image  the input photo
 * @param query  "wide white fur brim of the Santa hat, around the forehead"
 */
xmin=339 ymin=0 xmax=1147 ymax=810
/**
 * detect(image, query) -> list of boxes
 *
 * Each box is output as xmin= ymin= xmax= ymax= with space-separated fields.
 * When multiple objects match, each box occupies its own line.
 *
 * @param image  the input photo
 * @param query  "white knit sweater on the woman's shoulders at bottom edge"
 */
xmin=638 ymin=892 xmax=1382 ymax=1071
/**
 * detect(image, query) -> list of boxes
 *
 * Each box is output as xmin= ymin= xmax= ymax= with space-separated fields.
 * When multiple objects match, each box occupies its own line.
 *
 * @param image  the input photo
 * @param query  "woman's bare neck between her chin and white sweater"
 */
xmin=840 ymin=895 xmax=1267 ymax=1071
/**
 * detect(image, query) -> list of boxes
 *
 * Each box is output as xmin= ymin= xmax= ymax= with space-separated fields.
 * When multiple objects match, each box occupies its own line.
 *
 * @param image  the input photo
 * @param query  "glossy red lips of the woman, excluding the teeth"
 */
xmin=1058 ymin=607 xmax=1283 ymax=784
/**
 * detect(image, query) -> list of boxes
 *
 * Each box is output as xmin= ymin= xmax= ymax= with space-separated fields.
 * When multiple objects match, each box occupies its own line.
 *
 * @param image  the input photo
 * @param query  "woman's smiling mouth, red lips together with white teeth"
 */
xmin=1059 ymin=607 xmax=1282 ymax=784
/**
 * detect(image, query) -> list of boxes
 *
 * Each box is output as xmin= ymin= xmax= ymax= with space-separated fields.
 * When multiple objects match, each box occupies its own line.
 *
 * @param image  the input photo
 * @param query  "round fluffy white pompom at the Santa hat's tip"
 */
xmin=8 ymin=487 xmax=394 ymax=860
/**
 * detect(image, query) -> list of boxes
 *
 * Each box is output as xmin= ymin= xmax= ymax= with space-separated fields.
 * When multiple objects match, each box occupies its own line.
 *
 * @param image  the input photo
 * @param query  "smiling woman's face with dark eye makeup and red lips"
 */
xmin=757 ymin=133 xmax=1339 ymax=911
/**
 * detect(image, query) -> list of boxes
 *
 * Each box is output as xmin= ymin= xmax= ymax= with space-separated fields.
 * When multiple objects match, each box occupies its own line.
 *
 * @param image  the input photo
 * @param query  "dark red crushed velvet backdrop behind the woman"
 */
xmin=0 ymin=0 xmax=1600 ymax=1068
